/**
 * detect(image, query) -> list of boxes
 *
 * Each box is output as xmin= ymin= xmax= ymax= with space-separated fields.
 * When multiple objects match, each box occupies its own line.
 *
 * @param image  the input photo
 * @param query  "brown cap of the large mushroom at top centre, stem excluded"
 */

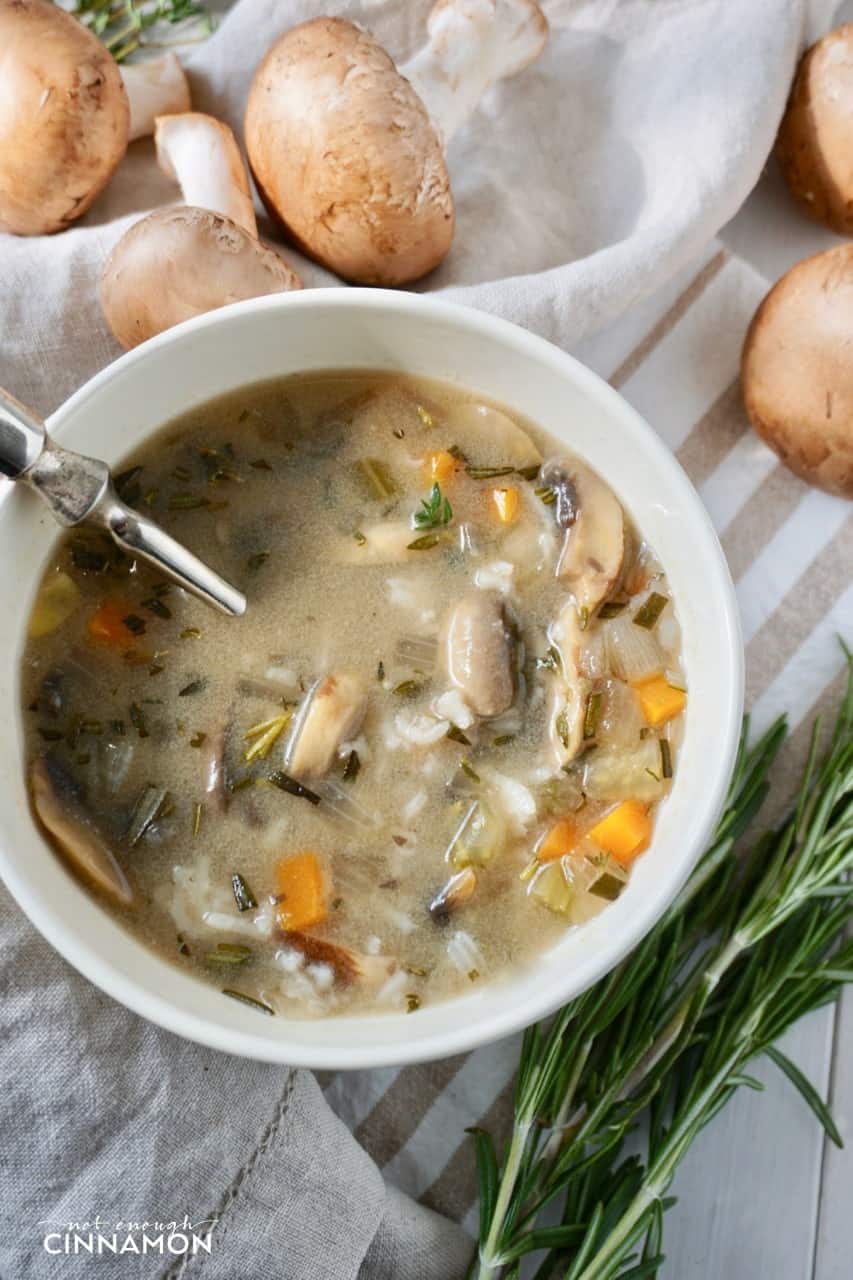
xmin=246 ymin=18 xmax=453 ymax=284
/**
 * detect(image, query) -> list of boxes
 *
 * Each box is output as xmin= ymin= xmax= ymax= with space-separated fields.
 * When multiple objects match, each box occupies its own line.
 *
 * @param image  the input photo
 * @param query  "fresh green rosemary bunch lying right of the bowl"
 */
xmin=471 ymin=650 xmax=853 ymax=1280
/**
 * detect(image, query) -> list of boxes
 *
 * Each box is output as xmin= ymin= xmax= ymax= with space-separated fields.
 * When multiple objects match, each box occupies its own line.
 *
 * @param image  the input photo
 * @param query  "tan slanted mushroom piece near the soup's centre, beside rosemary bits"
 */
xmin=284 ymin=671 xmax=368 ymax=778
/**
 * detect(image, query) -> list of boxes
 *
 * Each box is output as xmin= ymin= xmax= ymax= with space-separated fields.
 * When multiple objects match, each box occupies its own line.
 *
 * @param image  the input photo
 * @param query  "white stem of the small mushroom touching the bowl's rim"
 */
xmin=154 ymin=111 xmax=257 ymax=237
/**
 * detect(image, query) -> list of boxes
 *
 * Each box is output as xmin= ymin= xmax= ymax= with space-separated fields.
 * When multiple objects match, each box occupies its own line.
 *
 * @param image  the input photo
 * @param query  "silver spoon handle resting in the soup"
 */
xmin=0 ymin=387 xmax=246 ymax=617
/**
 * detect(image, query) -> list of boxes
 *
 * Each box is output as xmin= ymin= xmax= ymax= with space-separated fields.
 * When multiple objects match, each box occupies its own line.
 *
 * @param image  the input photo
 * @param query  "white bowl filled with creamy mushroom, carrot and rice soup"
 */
xmin=0 ymin=289 xmax=743 ymax=1069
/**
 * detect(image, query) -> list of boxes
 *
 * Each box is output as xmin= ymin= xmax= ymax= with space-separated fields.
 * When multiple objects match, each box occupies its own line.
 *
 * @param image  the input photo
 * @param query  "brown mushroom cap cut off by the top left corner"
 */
xmin=0 ymin=0 xmax=129 ymax=236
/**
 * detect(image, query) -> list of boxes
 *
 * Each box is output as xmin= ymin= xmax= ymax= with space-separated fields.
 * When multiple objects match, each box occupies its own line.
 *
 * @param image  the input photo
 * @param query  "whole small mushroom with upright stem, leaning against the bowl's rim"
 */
xmin=100 ymin=111 xmax=301 ymax=347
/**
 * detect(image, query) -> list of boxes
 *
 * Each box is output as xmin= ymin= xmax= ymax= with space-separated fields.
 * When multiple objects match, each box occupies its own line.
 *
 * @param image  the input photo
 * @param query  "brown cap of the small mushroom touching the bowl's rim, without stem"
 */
xmin=100 ymin=205 xmax=301 ymax=347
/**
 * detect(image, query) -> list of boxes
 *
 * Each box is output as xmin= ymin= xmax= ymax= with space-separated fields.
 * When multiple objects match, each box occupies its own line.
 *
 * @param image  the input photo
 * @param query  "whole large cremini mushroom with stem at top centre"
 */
xmin=246 ymin=0 xmax=547 ymax=284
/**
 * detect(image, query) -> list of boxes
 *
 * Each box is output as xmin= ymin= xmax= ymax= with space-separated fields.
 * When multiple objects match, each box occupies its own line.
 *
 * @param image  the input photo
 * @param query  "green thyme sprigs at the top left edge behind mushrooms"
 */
xmin=70 ymin=0 xmax=213 ymax=63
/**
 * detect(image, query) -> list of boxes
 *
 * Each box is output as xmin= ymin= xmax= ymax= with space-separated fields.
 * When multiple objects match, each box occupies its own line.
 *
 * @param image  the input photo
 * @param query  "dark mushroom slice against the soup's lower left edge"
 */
xmin=29 ymin=755 xmax=133 ymax=906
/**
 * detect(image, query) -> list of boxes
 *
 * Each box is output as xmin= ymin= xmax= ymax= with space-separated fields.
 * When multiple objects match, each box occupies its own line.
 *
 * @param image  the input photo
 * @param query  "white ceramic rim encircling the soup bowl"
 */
xmin=0 ymin=288 xmax=744 ymax=1070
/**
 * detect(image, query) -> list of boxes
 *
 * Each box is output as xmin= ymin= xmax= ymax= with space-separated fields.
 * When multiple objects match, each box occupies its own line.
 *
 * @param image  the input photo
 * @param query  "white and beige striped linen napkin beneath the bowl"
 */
xmin=323 ymin=243 xmax=853 ymax=1234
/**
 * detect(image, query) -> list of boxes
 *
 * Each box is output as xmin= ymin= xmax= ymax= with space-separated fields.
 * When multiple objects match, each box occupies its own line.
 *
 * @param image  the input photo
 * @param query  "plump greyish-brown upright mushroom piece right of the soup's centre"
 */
xmin=438 ymin=590 xmax=517 ymax=718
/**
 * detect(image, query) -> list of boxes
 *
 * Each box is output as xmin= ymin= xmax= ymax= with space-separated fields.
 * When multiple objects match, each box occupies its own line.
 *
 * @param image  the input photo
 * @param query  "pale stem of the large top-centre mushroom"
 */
xmin=400 ymin=0 xmax=548 ymax=147
